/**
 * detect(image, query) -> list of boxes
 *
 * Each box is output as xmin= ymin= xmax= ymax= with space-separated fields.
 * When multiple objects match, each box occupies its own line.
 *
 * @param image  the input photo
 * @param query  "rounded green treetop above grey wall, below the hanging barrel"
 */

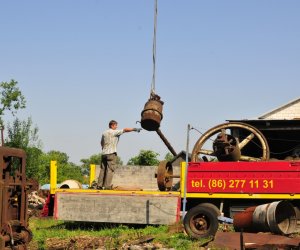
xmin=127 ymin=150 xmax=159 ymax=166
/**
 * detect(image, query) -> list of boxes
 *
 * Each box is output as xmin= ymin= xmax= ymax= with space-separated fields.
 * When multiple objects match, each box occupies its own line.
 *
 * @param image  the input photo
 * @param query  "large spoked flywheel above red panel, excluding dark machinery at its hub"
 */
xmin=191 ymin=122 xmax=270 ymax=162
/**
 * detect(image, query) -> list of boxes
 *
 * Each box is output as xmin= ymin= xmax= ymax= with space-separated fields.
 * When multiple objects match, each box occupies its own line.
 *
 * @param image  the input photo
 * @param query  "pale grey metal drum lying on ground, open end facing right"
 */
xmin=253 ymin=201 xmax=297 ymax=234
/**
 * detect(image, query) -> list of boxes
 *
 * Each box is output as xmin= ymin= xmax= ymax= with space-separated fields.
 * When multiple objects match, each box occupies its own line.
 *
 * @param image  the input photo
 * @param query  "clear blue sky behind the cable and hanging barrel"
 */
xmin=0 ymin=0 xmax=300 ymax=163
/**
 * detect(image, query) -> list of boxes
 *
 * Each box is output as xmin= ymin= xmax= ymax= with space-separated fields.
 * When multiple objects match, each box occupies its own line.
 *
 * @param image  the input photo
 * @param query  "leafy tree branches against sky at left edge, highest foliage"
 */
xmin=0 ymin=80 xmax=26 ymax=128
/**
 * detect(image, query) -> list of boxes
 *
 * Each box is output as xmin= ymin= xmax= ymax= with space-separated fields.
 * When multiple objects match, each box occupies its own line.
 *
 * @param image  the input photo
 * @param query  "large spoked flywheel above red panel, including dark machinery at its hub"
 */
xmin=191 ymin=122 xmax=270 ymax=162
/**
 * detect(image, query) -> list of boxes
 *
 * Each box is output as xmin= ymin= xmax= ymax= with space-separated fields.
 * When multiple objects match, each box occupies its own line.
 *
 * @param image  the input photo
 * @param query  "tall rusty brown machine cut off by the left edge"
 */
xmin=0 ymin=147 xmax=36 ymax=249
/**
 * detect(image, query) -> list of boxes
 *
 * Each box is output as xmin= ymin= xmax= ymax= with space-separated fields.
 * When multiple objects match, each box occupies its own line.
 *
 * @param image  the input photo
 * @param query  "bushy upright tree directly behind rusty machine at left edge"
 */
xmin=5 ymin=118 xmax=43 ymax=179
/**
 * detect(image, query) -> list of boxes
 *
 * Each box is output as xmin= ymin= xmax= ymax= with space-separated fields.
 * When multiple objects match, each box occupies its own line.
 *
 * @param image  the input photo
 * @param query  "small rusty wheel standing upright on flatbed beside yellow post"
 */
xmin=157 ymin=160 xmax=173 ymax=191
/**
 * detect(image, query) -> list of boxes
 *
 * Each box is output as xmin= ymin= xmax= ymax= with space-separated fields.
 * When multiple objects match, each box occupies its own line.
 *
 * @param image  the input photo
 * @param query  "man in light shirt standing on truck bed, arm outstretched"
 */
xmin=97 ymin=120 xmax=142 ymax=189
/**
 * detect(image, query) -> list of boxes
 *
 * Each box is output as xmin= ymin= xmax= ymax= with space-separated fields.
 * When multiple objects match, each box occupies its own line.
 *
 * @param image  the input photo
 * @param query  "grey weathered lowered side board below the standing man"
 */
xmin=54 ymin=192 xmax=180 ymax=225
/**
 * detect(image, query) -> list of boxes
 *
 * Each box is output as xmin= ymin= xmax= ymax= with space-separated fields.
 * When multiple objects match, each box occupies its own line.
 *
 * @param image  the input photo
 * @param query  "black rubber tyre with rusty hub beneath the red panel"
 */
xmin=183 ymin=203 xmax=219 ymax=239
